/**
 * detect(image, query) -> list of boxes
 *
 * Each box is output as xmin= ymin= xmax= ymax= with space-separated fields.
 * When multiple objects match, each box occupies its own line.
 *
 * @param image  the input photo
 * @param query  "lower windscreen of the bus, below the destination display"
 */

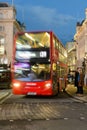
xmin=14 ymin=63 xmax=50 ymax=81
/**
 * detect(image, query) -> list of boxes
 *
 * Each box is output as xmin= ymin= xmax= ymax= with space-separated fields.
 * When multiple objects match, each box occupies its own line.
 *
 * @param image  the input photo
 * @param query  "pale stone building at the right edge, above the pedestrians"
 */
xmin=74 ymin=9 xmax=87 ymax=73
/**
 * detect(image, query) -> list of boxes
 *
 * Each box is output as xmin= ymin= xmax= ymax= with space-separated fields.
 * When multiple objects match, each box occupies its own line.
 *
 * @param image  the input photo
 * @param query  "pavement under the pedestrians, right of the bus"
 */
xmin=66 ymin=84 xmax=87 ymax=102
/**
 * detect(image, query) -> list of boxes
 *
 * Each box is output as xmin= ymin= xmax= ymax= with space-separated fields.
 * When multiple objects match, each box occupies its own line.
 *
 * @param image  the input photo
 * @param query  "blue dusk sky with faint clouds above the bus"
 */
xmin=0 ymin=0 xmax=87 ymax=44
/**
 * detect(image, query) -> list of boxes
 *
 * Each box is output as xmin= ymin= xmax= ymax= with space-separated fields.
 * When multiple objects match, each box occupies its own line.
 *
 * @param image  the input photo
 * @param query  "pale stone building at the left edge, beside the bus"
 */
xmin=0 ymin=2 xmax=23 ymax=64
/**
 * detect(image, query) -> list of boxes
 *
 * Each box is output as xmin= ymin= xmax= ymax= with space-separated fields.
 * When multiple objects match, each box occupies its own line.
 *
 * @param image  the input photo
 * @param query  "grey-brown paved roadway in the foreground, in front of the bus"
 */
xmin=0 ymin=89 xmax=87 ymax=130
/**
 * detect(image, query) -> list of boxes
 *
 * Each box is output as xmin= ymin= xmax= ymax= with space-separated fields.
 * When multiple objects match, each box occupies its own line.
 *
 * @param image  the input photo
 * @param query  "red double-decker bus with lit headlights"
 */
xmin=12 ymin=31 xmax=67 ymax=95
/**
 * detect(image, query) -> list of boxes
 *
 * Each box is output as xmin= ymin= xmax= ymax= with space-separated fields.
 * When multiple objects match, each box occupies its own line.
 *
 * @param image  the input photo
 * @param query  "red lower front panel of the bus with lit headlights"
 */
xmin=12 ymin=80 xmax=53 ymax=95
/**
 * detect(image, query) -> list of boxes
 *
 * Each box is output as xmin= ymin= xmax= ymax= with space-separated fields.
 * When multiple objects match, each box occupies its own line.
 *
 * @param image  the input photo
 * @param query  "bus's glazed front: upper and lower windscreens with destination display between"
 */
xmin=14 ymin=32 xmax=50 ymax=81
